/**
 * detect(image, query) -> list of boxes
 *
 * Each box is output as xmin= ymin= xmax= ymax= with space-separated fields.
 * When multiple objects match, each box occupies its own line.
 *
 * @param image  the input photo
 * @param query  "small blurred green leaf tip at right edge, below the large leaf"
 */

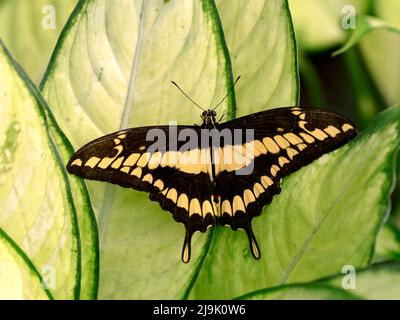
xmin=373 ymin=223 xmax=400 ymax=263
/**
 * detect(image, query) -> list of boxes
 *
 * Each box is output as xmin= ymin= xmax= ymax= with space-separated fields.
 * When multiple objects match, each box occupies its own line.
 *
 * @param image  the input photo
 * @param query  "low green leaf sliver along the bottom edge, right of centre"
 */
xmin=237 ymin=283 xmax=359 ymax=300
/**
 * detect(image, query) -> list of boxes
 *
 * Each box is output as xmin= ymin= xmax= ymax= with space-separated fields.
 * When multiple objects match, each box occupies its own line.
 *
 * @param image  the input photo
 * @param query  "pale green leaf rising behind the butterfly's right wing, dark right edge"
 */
xmin=216 ymin=0 xmax=299 ymax=112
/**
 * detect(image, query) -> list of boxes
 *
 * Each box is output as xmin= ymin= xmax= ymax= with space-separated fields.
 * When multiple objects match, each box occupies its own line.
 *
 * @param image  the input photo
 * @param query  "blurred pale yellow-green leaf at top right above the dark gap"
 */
xmin=289 ymin=0 xmax=369 ymax=51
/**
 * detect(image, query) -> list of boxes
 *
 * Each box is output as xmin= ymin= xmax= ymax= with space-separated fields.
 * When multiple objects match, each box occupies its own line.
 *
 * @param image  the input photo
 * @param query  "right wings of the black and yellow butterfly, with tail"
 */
xmin=216 ymin=107 xmax=357 ymax=258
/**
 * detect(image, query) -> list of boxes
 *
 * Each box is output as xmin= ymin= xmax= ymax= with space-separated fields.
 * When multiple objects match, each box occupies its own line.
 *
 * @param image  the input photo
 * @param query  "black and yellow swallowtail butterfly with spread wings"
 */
xmin=67 ymin=107 xmax=357 ymax=262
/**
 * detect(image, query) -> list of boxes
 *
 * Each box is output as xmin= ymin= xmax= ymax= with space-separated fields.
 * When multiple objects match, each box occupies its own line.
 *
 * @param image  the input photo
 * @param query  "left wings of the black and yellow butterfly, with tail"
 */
xmin=67 ymin=126 xmax=215 ymax=262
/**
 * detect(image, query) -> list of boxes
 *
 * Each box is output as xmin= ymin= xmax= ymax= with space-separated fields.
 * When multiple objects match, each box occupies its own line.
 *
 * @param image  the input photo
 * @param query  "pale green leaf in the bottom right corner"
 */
xmin=323 ymin=262 xmax=400 ymax=300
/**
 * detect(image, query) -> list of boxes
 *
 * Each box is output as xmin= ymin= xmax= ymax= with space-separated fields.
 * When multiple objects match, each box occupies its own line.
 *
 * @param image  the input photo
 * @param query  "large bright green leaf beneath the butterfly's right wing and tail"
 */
xmin=191 ymin=107 xmax=400 ymax=299
